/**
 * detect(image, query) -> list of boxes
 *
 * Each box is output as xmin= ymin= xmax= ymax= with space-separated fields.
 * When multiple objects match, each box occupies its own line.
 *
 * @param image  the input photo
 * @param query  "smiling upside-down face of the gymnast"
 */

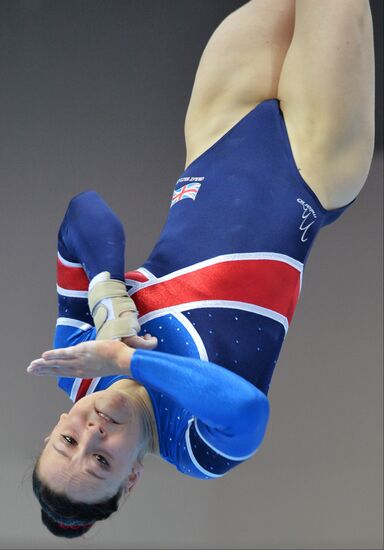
xmin=39 ymin=388 xmax=143 ymax=503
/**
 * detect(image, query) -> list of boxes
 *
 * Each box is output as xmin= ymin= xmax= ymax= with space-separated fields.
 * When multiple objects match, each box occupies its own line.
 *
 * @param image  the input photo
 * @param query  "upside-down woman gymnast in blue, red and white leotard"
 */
xmin=28 ymin=0 xmax=374 ymax=537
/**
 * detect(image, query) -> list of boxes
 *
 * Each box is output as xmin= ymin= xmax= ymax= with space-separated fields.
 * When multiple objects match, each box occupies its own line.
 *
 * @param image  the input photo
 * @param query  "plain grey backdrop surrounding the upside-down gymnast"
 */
xmin=0 ymin=0 xmax=383 ymax=548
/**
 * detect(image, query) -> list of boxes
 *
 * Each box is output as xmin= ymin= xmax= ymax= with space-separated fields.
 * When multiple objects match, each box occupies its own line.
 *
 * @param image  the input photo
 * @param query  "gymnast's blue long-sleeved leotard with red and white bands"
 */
xmin=54 ymin=99 xmax=354 ymax=484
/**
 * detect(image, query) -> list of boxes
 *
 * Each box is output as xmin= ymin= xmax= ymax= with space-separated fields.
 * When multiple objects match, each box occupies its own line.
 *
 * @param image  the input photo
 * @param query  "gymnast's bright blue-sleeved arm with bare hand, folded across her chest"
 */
xmin=27 ymin=340 xmax=269 ymax=460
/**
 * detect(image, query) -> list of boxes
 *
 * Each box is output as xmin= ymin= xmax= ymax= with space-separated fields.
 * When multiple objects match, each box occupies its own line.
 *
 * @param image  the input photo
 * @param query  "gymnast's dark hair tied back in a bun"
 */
xmin=32 ymin=459 xmax=123 ymax=539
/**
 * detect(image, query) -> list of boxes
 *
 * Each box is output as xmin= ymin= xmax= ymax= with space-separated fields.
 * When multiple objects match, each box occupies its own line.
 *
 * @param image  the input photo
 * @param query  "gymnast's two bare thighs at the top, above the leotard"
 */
xmin=185 ymin=0 xmax=373 ymax=210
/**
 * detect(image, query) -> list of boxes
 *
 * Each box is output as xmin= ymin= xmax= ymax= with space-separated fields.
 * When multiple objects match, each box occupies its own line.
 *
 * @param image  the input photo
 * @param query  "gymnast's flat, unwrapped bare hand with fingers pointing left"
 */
xmin=27 ymin=340 xmax=135 ymax=378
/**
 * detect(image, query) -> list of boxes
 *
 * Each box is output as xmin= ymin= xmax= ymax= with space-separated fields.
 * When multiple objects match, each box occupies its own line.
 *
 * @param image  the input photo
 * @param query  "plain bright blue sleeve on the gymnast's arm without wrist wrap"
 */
xmin=131 ymin=350 xmax=269 ymax=459
